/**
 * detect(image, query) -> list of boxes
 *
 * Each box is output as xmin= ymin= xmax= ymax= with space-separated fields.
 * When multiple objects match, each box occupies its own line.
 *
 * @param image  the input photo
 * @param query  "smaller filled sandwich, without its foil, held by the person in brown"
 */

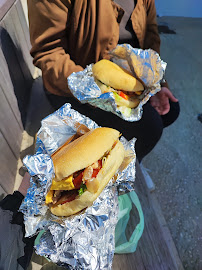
xmin=92 ymin=59 xmax=144 ymax=115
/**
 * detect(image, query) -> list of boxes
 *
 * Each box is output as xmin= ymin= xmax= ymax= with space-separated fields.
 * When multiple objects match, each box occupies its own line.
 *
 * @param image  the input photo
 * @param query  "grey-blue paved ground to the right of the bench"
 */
xmin=143 ymin=17 xmax=202 ymax=270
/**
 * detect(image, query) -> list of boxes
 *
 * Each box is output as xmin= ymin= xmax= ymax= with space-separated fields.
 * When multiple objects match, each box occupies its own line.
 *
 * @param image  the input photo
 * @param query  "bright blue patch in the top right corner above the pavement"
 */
xmin=155 ymin=0 xmax=202 ymax=18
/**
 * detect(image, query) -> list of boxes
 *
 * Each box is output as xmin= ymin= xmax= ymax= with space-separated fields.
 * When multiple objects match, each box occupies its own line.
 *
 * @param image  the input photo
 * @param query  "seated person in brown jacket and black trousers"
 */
xmin=28 ymin=0 xmax=179 ymax=161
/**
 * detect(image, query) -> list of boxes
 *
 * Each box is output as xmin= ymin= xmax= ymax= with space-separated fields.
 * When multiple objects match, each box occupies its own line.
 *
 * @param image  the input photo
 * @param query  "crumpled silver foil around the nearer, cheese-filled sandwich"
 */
xmin=20 ymin=103 xmax=136 ymax=270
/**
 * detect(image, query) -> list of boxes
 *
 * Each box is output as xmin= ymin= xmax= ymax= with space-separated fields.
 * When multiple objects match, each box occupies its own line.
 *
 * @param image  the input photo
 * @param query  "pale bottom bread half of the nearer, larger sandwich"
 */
xmin=50 ymin=141 xmax=125 ymax=216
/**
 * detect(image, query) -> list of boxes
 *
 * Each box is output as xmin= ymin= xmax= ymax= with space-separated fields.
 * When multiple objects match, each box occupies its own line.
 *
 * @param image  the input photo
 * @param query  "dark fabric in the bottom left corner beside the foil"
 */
xmin=0 ymin=191 xmax=36 ymax=270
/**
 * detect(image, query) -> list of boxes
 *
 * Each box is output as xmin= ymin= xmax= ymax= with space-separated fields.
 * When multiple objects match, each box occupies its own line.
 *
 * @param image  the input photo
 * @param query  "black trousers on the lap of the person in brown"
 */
xmin=45 ymin=91 xmax=180 ymax=161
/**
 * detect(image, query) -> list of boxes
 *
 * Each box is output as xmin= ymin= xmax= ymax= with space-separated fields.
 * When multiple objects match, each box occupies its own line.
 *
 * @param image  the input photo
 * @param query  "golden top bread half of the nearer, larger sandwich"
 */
xmin=52 ymin=128 xmax=120 ymax=181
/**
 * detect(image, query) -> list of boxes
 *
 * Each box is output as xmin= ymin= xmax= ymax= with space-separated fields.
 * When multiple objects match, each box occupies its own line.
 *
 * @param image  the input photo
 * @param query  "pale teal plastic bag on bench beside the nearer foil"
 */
xmin=115 ymin=191 xmax=144 ymax=254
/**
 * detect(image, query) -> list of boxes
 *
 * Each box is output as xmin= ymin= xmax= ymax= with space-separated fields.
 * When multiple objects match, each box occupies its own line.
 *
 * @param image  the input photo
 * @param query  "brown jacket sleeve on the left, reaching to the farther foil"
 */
xmin=28 ymin=0 xmax=83 ymax=96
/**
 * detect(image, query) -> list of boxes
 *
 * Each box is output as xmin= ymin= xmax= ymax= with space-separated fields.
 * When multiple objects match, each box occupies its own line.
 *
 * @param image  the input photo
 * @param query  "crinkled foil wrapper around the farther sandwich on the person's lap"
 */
xmin=67 ymin=44 xmax=167 ymax=122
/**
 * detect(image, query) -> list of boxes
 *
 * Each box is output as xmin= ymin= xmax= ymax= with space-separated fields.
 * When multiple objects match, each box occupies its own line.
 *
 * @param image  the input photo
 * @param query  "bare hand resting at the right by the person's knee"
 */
xmin=150 ymin=87 xmax=178 ymax=115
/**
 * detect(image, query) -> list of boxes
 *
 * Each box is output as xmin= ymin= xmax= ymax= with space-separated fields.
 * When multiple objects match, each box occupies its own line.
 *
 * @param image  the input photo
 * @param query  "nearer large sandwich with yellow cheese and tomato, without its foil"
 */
xmin=46 ymin=128 xmax=125 ymax=216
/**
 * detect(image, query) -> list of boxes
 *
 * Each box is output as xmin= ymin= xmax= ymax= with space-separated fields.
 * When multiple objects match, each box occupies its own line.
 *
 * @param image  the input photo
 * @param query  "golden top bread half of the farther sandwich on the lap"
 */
xmin=92 ymin=59 xmax=144 ymax=92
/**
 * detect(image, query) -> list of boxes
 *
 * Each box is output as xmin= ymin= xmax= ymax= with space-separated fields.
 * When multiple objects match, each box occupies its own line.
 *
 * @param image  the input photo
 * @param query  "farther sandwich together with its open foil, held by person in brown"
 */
xmin=67 ymin=44 xmax=166 ymax=122
